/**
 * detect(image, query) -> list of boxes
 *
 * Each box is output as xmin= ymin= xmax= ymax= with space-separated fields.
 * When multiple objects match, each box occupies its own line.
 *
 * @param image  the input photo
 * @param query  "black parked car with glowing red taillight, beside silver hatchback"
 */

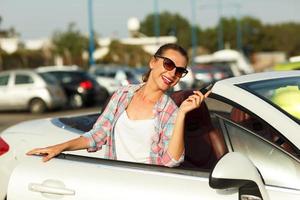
xmin=37 ymin=66 xmax=109 ymax=108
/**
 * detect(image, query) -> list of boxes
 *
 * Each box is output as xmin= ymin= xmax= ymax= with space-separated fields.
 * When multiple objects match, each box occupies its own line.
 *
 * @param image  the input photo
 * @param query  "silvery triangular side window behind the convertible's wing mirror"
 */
xmin=225 ymin=121 xmax=300 ymax=189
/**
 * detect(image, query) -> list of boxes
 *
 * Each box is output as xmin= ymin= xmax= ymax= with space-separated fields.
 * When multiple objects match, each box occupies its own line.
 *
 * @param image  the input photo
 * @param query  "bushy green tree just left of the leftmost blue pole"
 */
xmin=52 ymin=23 xmax=89 ymax=65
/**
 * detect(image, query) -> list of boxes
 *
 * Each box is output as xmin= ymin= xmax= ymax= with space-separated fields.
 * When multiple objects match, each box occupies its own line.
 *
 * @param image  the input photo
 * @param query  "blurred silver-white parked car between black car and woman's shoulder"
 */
xmin=89 ymin=65 xmax=140 ymax=94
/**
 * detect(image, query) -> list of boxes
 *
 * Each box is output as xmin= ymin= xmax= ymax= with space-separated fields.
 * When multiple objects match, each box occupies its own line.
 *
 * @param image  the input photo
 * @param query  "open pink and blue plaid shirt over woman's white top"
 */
xmin=83 ymin=84 xmax=183 ymax=167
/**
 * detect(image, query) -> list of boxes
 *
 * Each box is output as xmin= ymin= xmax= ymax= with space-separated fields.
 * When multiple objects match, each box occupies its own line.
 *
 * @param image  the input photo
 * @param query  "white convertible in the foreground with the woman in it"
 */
xmin=0 ymin=71 xmax=300 ymax=200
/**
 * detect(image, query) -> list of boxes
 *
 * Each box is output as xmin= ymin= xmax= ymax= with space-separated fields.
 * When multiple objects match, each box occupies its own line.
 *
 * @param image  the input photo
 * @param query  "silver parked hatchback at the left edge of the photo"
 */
xmin=0 ymin=70 xmax=66 ymax=113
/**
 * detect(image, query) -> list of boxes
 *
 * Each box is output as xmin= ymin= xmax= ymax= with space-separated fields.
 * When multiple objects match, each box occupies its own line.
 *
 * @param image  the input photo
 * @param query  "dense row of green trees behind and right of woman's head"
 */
xmin=141 ymin=12 xmax=300 ymax=56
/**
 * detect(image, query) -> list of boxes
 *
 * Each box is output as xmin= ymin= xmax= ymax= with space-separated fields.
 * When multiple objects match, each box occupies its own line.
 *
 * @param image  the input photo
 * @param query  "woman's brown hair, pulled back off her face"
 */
xmin=142 ymin=43 xmax=189 ymax=82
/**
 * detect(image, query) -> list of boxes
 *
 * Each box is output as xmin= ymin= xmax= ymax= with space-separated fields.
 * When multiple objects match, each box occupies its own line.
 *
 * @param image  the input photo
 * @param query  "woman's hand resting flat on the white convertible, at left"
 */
xmin=26 ymin=145 xmax=63 ymax=162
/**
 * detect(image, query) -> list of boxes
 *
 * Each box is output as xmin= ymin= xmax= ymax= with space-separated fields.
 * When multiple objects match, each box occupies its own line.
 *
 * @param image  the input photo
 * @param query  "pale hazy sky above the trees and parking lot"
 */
xmin=0 ymin=0 xmax=300 ymax=40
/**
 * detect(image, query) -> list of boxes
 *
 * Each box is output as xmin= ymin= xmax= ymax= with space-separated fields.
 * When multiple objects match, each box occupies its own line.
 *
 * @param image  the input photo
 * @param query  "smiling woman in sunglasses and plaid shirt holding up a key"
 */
xmin=27 ymin=44 xmax=209 ymax=167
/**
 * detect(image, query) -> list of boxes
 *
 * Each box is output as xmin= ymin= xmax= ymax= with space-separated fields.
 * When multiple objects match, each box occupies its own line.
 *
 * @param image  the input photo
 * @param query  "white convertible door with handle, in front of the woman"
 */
xmin=7 ymin=155 xmax=238 ymax=200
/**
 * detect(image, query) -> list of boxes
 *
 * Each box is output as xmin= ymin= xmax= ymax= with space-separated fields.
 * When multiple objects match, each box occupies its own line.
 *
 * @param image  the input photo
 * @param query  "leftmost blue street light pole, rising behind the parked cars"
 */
xmin=88 ymin=0 xmax=95 ymax=66
